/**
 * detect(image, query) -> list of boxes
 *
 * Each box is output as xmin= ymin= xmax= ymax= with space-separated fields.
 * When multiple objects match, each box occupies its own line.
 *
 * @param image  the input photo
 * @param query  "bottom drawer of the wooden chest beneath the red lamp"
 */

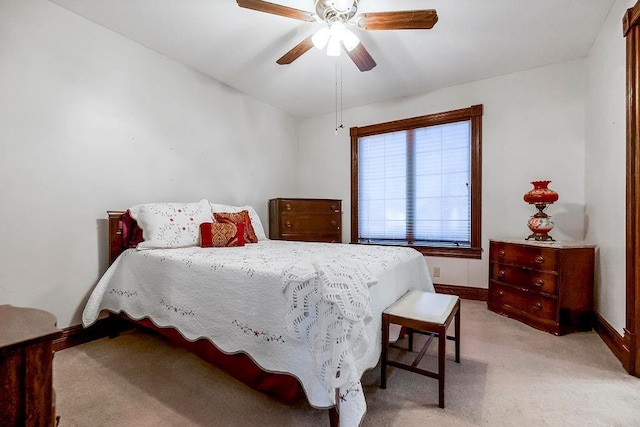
xmin=489 ymin=282 xmax=558 ymax=321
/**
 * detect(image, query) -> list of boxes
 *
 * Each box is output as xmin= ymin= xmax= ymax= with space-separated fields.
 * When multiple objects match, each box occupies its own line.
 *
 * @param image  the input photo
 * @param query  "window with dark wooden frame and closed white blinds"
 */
xmin=351 ymin=105 xmax=482 ymax=258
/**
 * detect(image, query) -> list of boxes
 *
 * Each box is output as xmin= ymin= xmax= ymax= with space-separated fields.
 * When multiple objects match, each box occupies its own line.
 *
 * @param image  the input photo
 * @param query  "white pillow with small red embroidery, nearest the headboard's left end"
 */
xmin=129 ymin=199 xmax=211 ymax=250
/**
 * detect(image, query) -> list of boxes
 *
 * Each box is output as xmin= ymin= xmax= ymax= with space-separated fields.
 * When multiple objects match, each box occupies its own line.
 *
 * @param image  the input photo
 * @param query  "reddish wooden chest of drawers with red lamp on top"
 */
xmin=488 ymin=240 xmax=595 ymax=335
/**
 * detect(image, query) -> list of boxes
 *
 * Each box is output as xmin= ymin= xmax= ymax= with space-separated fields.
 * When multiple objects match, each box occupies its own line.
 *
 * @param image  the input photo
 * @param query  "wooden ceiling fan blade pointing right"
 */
xmin=357 ymin=9 xmax=438 ymax=30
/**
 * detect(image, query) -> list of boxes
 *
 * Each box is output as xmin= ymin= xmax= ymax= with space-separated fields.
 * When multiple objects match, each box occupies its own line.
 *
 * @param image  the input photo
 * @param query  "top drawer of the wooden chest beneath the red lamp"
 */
xmin=490 ymin=242 xmax=558 ymax=271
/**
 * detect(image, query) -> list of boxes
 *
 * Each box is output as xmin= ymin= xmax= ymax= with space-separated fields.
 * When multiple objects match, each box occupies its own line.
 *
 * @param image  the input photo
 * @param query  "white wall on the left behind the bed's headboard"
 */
xmin=0 ymin=0 xmax=298 ymax=327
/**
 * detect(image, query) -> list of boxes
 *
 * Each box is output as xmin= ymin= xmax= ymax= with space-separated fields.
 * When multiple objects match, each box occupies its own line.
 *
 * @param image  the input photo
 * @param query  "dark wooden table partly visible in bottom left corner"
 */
xmin=0 ymin=304 xmax=62 ymax=427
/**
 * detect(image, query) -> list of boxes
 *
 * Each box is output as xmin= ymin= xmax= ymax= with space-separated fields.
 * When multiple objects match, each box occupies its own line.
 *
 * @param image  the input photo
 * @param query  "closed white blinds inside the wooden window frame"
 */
xmin=358 ymin=121 xmax=471 ymax=246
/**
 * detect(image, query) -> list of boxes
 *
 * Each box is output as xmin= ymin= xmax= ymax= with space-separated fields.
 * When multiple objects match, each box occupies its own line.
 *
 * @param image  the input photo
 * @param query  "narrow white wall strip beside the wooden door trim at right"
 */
xmin=585 ymin=0 xmax=635 ymax=334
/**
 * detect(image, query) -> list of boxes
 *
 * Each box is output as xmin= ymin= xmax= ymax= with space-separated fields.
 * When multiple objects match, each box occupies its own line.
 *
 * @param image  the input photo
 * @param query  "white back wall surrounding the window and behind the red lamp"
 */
xmin=299 ymin=60 xmax=587 ymax=288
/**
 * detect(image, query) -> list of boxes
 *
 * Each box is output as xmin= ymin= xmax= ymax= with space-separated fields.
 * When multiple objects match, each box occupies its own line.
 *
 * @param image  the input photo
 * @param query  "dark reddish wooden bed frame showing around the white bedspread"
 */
xmin=107 ymin=211 xmax=339 ymax=427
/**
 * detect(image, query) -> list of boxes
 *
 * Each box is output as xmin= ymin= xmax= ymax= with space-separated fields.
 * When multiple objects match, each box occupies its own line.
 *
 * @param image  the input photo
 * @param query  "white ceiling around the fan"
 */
xmin=52 ymin=0 xmax=615 ymax=117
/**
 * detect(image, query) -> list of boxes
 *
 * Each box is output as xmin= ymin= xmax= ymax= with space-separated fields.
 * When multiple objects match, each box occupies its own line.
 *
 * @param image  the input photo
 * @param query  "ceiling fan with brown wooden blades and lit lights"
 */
xmin=237 ymin=0 xmax=438 ymax=71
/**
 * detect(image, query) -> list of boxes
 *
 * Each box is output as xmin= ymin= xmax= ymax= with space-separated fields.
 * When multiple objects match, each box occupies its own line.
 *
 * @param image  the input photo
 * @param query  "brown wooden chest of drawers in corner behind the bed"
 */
xmin=269 ymin=199 xmax=342 ymax=243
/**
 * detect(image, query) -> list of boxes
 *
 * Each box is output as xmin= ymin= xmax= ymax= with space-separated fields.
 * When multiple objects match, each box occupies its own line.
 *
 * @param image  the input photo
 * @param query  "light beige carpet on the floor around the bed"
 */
xmin=54 ymin=300 xmax=640 ymax=427
